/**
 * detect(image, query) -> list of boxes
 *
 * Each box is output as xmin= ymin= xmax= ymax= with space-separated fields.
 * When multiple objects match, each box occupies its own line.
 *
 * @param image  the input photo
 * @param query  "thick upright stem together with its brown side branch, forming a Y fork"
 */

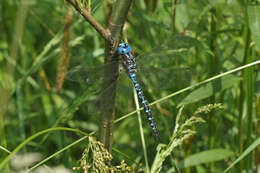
xmin=66 ymin=0 xmax=132 ymax=152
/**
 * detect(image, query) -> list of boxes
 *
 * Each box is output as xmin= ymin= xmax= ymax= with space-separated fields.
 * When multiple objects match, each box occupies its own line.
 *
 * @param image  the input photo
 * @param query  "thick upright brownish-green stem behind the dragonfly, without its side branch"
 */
xmin=99 ymin=0 xmax=132 ymax=152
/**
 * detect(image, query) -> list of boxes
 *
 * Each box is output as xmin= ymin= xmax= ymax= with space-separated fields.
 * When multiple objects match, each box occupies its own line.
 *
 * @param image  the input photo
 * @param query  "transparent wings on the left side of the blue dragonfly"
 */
xmin=66 ymin=62 xmax=125 ymax=115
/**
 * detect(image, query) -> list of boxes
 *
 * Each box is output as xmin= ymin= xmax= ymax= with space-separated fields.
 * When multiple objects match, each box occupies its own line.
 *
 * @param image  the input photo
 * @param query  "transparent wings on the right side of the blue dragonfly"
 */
xmin=132 ymin=35 xmax=200 ymax=92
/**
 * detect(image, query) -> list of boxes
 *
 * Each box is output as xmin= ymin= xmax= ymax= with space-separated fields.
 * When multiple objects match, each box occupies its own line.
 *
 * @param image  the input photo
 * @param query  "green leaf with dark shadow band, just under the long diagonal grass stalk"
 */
xmin=178 ymin=75 xmax=240 ymax=107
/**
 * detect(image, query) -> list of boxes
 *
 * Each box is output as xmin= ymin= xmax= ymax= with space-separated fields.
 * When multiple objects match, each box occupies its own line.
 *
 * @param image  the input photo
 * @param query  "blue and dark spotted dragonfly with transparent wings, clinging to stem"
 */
xmin=67 ymin=35 xmax=199 ymax=139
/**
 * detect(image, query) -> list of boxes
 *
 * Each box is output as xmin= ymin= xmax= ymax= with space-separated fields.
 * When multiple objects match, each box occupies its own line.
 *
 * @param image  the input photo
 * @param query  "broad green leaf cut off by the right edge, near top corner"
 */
xmin=247 ymin=5 xmax=260 ymax=49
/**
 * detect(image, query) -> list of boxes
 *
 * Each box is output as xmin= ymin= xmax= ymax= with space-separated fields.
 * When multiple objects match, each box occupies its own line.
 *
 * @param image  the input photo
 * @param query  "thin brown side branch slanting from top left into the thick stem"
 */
xmin=66 ymin=0 xmax=111 ymax=41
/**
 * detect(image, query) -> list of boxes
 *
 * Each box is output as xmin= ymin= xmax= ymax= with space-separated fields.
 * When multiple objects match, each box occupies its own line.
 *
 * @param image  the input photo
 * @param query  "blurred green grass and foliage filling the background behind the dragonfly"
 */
xmin=0 ymin=0 xmax=260 ymax=173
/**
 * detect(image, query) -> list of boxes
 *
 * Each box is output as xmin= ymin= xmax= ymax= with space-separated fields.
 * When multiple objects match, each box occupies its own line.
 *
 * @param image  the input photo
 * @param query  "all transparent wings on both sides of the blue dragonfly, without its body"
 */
xmin=66 ymin=36 xmax=199 ymax=113
